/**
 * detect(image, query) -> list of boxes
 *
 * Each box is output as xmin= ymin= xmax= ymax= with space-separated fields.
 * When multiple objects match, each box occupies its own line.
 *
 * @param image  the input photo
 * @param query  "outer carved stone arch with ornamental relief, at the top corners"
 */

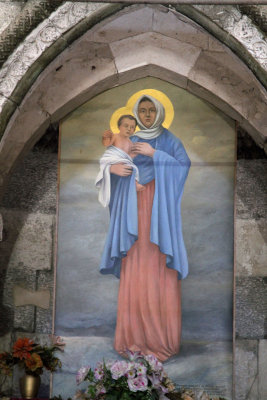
xmin=0 ymin=0 xmax=267 ymax=139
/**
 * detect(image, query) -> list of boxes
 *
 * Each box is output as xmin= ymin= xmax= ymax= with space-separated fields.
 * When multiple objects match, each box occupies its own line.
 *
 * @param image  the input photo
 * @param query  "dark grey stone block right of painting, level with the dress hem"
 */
xmin=235 ymin=277 xmax=267 ymax=339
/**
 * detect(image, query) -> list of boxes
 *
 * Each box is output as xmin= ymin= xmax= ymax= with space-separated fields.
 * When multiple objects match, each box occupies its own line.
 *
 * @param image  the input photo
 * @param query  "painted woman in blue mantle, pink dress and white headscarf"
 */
xmin=96 ymin=95 xmax=190 ymax=361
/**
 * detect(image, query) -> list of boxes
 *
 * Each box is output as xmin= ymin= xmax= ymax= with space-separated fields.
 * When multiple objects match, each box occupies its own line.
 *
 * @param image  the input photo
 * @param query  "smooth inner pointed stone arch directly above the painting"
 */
xmin=0 ymin=3 xmax=267 ymax=197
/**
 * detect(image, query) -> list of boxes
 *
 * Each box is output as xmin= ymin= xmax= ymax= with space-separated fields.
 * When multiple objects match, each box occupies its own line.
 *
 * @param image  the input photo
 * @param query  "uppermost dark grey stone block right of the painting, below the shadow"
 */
xmin=236 ymin=160 xmax=267 ymax=220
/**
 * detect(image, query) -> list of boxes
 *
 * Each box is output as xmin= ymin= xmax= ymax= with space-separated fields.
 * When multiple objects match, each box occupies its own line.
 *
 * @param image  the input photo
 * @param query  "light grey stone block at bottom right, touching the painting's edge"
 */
xmin=234 ymin=340 xmax=258 ymax=400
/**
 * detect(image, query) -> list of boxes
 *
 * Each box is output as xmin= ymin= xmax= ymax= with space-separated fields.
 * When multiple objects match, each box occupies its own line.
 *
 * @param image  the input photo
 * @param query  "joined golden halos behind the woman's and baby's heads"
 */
xmin=109 ymin=89 xmax=174 ymax=133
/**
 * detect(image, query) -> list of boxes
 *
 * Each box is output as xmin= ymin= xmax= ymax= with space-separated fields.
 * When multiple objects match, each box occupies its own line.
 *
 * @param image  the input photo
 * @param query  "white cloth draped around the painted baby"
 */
xmin=95 ymin=146 xmax=139 ymax=207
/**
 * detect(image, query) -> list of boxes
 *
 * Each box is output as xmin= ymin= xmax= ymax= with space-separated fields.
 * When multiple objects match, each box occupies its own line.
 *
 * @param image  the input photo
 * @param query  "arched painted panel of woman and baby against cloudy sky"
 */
xmin=53 ymin=78 xmax=235 ymax=398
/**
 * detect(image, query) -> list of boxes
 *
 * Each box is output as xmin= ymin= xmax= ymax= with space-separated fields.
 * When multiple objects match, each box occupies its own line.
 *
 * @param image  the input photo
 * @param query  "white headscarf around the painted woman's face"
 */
xmin=133 ymin=94 xmax=165 ymax=139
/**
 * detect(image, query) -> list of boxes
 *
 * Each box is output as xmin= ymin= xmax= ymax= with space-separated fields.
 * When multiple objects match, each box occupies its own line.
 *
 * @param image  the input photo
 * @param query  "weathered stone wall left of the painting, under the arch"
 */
xmin=0 ymin=129 xmax=57 ymax=397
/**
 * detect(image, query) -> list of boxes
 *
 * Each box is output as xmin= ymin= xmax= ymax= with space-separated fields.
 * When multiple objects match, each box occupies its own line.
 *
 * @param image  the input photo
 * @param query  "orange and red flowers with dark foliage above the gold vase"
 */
xmin=0 ymin=337 xmax=64 ymax=376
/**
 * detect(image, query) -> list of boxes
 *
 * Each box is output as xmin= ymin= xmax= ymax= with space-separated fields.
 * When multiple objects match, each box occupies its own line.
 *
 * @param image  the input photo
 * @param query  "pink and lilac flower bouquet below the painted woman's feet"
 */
xmin=76 ymin=351 xmax=175 ymax=400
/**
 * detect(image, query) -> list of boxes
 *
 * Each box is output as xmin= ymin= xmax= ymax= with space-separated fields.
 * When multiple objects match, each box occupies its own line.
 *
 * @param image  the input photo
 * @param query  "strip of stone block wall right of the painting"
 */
xmin=237 ymin=140 xmax=267 ymax=400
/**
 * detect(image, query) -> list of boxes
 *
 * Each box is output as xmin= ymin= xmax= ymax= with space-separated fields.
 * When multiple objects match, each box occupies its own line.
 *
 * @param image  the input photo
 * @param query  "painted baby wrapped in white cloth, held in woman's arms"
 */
xmin=95 ymin=115 xmax=145 ymax=207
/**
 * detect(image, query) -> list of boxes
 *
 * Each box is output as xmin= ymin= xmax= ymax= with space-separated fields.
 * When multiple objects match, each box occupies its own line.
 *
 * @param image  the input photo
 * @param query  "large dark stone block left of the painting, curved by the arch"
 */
xmin=2 ymin=152 xmax=57 ymax=214
